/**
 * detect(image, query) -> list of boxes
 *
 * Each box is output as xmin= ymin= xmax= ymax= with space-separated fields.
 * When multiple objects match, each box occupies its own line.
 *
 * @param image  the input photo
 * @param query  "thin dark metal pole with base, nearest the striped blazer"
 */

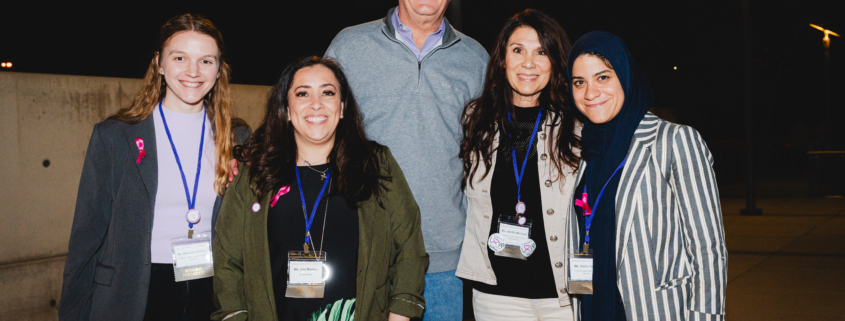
xmin=739 ymin=0 xmax=763 ymax=215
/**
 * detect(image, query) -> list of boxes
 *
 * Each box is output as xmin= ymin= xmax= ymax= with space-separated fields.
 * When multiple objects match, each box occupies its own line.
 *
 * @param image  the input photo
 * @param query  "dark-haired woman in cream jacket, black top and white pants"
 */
xmin=457 ymin=9 xmax=579 ymax=320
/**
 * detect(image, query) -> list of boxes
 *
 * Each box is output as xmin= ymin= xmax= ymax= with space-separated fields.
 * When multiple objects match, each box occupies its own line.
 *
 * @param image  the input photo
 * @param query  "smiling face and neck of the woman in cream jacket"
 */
xmin=505 ymin=27 xmax=552 ymax=107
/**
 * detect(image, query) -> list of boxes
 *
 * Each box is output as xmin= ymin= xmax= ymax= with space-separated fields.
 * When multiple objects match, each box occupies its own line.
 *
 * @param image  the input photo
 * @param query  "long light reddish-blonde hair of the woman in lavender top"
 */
xmin=109 ymin=13 xmax=235 ymax=195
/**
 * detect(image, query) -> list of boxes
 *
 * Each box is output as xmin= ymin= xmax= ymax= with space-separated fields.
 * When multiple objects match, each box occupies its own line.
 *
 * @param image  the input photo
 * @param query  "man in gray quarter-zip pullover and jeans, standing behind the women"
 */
xmin=326 ymin=0 xmax=488 ymax=321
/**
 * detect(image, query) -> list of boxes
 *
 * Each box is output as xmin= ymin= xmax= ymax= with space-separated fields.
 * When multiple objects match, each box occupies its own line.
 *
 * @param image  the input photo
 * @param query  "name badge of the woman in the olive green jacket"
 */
xmin=285 ymin=251 xmax=331 ymax=299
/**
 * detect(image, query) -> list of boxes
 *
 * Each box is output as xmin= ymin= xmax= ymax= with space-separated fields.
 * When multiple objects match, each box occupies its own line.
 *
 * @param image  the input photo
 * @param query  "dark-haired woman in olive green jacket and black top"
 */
xmin=212 ymin=57 xmax=428 ymax=320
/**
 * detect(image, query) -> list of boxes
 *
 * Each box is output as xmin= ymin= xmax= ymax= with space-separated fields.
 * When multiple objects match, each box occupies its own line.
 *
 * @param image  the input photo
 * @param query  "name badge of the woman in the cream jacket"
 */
xmin=487 ymin=215 xmax=537 ymax=260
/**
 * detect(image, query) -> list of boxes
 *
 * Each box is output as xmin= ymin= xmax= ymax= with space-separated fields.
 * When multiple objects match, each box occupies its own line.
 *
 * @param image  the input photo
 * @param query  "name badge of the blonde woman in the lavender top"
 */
xmin=170 ymin=231 xmax=214 ymax=282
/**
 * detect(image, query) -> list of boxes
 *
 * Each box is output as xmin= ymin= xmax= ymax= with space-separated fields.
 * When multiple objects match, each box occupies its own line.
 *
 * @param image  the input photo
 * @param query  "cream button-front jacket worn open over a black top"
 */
xmin=456 ymin=115 xmax=581 ymax=306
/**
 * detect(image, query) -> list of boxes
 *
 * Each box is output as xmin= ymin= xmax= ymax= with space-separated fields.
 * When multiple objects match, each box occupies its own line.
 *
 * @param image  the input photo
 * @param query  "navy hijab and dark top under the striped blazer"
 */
xmin=567 ymin=31 xmax=653 ymax=321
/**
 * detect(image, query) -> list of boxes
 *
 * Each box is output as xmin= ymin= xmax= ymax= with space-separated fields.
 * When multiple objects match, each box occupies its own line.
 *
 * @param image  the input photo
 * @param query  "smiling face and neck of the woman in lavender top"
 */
xmin=158 ymin=31 xmax=220 ymax=113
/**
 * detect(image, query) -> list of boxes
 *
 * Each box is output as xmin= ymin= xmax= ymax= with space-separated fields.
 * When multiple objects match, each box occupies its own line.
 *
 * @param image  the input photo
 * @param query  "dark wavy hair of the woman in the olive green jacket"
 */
xmin=236 ymin=56 xmax=389 ymax=205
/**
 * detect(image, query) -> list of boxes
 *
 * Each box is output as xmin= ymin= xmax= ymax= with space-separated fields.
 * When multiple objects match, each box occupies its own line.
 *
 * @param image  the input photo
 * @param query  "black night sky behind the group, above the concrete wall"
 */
xmin=0 ymin=0 xmax=845 ymax=180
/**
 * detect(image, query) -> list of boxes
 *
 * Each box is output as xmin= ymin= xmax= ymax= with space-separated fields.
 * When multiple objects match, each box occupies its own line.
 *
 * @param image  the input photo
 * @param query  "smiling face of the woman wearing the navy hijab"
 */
xmin=572 ymin=54 xmax=625 ymax=124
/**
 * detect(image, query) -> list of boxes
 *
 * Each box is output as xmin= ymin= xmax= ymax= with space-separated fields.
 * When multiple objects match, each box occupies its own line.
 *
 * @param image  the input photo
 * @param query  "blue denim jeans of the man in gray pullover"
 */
xmin=423 ymin=270 xmax=464 ymax=321
